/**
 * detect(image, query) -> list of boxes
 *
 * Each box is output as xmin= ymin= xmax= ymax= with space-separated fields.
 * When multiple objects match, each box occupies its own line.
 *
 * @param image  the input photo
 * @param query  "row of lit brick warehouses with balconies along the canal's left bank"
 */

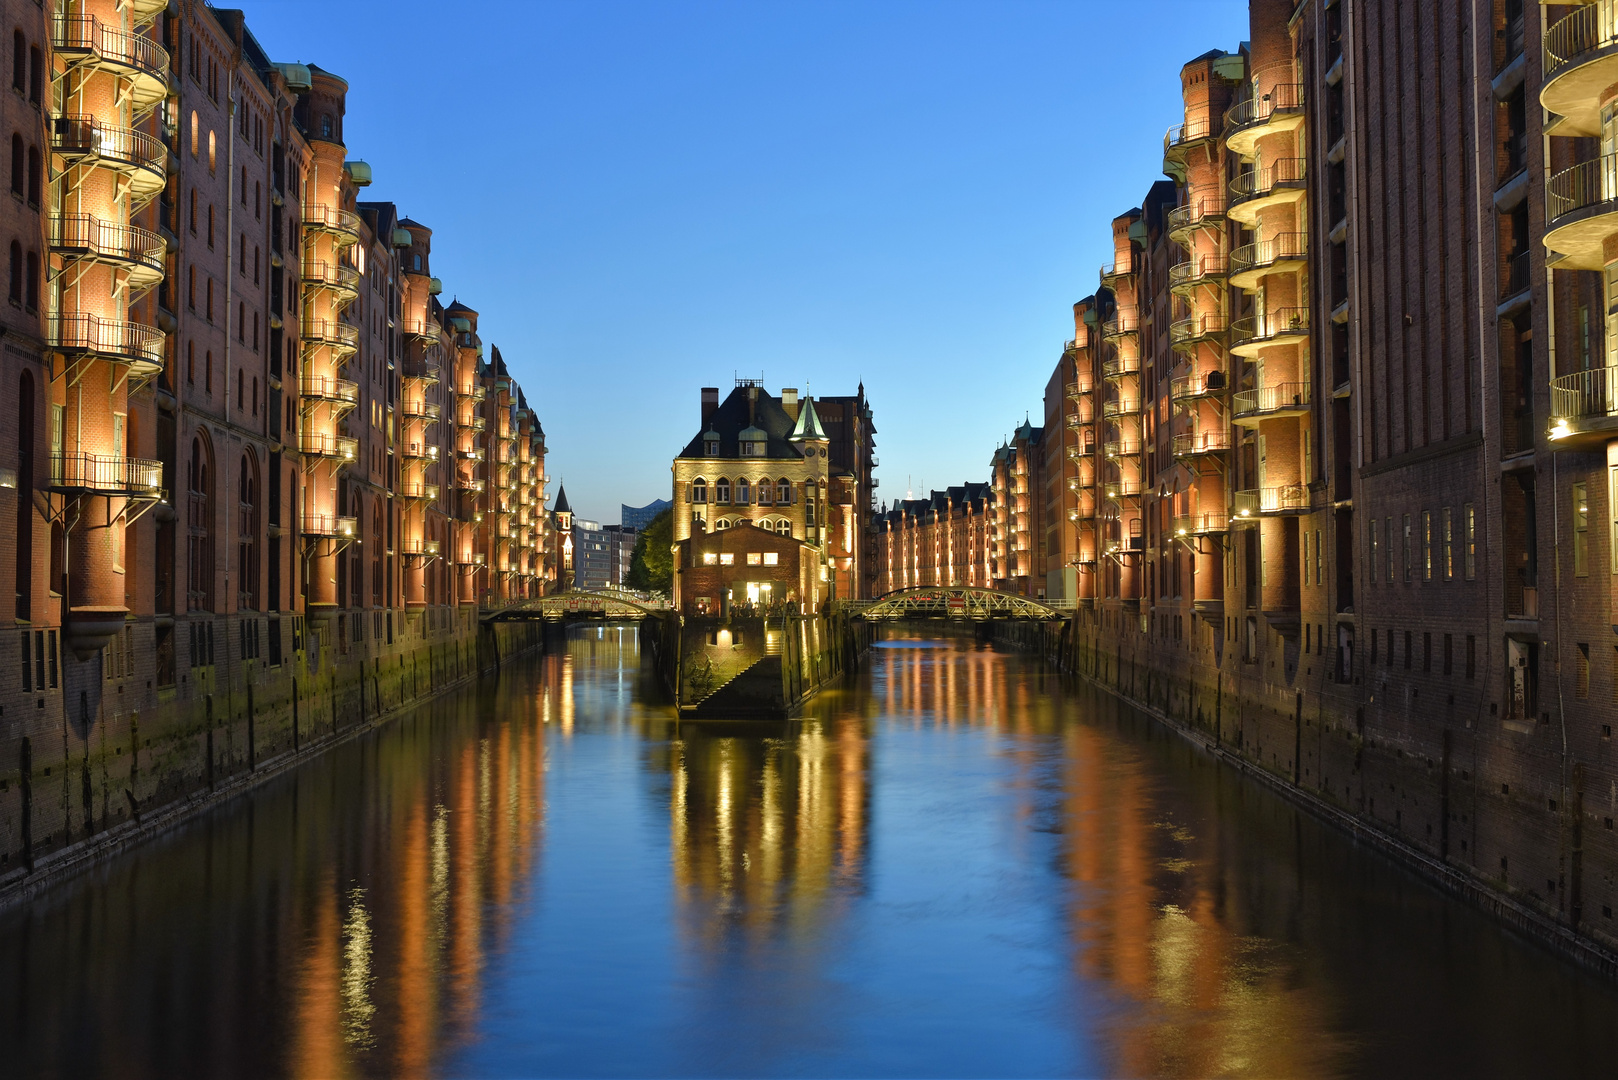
xmin=0 ymin=0 xmax=557 ymax=882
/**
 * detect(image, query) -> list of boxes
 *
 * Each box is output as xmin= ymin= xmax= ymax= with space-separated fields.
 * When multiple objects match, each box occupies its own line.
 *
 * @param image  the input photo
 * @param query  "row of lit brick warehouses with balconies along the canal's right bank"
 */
xmin=964 ymin=0 xmax=1618 ymax=949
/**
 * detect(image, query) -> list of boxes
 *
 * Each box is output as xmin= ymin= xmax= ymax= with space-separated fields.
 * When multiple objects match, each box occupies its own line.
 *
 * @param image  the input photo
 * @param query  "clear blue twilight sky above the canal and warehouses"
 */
xmin=239 ymin=0 xmax=1247 ymax=521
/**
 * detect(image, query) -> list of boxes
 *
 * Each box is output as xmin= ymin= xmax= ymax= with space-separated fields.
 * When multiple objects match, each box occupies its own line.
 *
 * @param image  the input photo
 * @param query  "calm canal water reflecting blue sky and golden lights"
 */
xmin=0 ymin=627 xmax=1618 ymax=1078
